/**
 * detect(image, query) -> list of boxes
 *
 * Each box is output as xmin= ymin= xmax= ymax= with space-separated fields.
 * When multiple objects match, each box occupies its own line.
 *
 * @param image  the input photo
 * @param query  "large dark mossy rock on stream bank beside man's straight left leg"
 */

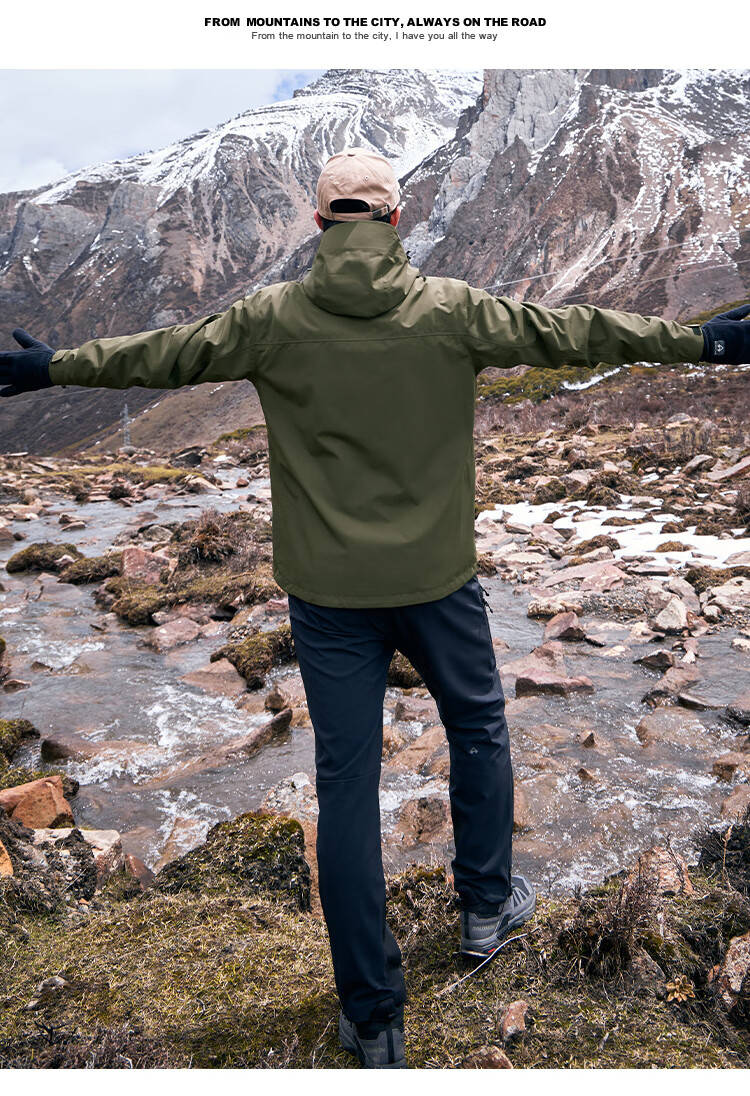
xmin=147 ymin=812 xmax=310 ymax=910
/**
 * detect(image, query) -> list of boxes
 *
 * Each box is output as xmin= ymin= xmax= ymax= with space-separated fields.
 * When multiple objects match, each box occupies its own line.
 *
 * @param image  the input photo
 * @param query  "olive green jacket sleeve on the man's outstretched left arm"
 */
xmin=49 ymin=297 xmax=259 ymax=388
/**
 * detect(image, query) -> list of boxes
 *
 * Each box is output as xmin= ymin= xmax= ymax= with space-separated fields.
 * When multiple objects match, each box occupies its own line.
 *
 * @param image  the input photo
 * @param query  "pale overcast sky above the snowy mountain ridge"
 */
xmin=0 ymin=69 xmax=320 ymax=193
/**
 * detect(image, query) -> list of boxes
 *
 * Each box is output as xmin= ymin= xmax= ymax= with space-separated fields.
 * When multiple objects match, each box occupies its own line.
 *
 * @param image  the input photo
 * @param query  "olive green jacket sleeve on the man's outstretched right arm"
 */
xmin=460 ymin=288 xmax=703 ymax=373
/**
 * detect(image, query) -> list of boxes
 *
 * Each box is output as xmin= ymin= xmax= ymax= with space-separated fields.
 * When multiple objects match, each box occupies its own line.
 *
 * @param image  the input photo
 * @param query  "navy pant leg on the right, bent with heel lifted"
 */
xmin=390 ymin=578 xmax=513 ymax=907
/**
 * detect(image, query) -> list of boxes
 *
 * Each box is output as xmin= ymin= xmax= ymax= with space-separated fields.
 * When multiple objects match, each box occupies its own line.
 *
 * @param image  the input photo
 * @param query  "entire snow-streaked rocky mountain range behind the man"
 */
xmin=0 ymin=69 xmax=750 ymax=452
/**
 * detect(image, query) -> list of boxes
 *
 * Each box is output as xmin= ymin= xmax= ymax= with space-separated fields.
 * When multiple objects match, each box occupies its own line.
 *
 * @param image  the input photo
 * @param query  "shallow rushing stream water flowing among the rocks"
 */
xmin=0 ymin=473 xmax=750 ymax=889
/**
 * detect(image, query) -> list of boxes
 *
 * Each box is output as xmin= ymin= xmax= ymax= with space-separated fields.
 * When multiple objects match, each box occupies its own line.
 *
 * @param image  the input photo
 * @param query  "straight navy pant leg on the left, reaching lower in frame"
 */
xmin=289 ymin=595 xmax=405 ymax=1023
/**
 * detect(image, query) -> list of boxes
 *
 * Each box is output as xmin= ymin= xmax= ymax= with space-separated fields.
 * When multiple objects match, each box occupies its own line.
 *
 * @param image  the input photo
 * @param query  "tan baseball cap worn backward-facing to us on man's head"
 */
xmin=317 ymin=148 xmax=401 ymax=220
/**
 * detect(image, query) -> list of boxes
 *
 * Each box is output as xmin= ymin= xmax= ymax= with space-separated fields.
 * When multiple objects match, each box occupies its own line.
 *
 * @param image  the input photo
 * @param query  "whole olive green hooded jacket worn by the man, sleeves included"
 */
xmin=50 ymin=221 xmax=703 ymax=607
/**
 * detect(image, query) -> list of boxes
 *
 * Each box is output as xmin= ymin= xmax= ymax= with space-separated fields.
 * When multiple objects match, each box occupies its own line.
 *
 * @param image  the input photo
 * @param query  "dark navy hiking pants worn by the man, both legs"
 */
xmin=289 ymin=576 xmax=513 ymax=1023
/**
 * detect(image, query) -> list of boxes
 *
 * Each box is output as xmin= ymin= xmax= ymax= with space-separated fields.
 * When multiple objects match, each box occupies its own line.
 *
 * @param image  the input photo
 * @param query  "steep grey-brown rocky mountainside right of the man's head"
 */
xmin=406 ymin=70 xmax=750 ymax=320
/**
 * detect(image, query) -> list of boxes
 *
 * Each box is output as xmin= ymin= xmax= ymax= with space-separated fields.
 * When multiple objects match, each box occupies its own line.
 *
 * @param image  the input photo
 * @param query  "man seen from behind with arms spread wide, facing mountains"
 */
xmin=0 ymin=149 xmax=750 ymax=1069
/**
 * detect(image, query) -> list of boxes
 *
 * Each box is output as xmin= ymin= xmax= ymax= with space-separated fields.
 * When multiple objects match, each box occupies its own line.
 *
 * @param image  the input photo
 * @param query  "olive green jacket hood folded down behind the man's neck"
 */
xmin=303 ymin=220 xmax=419 ymax=317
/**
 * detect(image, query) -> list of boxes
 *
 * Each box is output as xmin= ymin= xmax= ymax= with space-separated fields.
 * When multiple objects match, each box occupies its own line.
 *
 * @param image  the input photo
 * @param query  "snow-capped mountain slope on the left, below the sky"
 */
xmin=0 ymin=70 xmax=481 ymax=452
